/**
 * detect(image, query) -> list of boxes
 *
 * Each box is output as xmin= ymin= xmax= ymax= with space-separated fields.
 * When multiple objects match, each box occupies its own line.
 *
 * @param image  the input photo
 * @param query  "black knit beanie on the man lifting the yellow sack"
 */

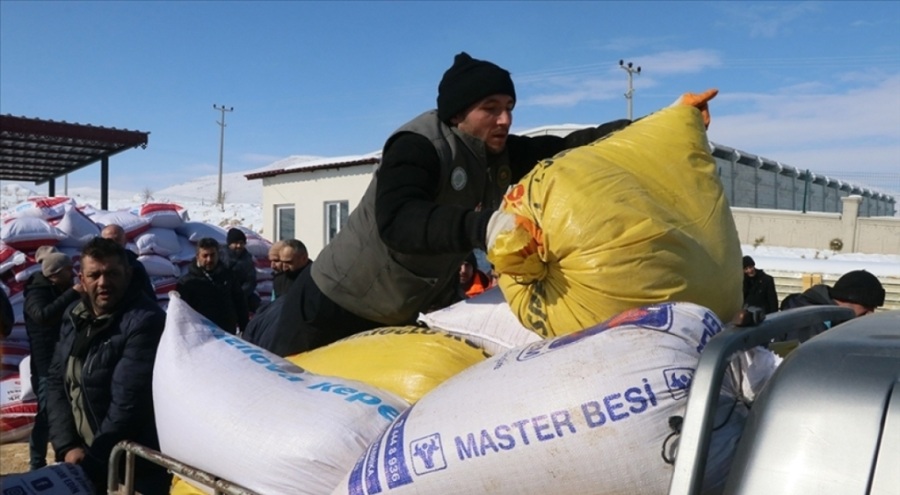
xmin=438 ymin=52 xmax=516 ymax=123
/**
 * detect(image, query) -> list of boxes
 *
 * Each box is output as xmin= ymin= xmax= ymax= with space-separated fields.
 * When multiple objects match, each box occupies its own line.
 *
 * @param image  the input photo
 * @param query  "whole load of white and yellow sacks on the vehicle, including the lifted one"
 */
xmin=154 ymin=101 xmax=760 ymax=495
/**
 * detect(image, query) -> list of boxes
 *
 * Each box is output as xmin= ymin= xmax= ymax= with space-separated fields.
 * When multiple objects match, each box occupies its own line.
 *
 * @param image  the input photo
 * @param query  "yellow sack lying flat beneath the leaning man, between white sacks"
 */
xmin=286 ymin=326 xmax=488 ymax=404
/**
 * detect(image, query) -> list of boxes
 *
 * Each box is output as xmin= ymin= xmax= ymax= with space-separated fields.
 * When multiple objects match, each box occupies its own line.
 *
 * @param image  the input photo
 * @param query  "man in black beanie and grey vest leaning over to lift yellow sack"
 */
xmin=278 ymin=52 xmax=630 ymax=352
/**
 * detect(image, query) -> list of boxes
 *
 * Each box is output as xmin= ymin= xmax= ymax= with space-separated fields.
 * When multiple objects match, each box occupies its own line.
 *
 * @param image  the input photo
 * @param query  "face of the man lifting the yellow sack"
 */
xmin=451 ymin=94 xmax=516 ymax=153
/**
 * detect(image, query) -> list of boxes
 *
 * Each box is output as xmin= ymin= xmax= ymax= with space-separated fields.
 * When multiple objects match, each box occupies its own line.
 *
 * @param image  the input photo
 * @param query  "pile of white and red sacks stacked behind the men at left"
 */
xmin=0 ymin=197 xmax=272 ymax=443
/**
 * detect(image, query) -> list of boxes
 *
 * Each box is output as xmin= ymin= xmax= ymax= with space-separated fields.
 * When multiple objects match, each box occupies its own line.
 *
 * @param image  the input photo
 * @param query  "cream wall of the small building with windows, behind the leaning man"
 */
xmin=263 ymin=165 xmax=375 ymax=259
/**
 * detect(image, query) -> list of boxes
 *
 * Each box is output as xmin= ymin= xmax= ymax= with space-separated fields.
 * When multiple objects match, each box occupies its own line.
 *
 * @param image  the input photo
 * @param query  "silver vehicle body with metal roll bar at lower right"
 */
xmin=669 ymin=306 xmax=900 ymax=495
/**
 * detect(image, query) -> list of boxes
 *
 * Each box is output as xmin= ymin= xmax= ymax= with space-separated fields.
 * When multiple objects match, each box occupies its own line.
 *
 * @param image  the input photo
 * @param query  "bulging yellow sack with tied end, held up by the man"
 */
xmin=488 ymin=105 xmax=742 ymax=337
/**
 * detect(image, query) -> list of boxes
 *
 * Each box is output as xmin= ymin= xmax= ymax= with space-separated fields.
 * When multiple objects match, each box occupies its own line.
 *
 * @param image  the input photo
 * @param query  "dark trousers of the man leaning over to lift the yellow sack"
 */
xmin=269 ymin=265 xmax=384 ymax=356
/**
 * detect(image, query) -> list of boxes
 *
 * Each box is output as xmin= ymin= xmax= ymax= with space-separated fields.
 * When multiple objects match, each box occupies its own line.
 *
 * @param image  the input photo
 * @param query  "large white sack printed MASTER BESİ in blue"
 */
xmin=333 ymin=303 xmax=746 ymax=495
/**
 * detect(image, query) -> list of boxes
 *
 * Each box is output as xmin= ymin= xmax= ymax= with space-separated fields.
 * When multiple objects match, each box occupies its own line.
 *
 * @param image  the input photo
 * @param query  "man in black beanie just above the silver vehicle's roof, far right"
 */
xmin=781 ymin=270 xmax=884 ymax=316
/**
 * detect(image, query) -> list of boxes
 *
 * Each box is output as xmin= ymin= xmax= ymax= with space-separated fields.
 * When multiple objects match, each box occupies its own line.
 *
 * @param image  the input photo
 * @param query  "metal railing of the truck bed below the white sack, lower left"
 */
xmin=107 ymin=440 xmax=259 ymax=495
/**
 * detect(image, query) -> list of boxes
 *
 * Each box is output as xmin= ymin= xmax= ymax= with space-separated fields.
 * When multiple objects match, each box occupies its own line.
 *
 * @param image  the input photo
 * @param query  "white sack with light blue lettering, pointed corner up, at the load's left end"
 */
xmin=153 ymin=292 xmax=408 ymax=495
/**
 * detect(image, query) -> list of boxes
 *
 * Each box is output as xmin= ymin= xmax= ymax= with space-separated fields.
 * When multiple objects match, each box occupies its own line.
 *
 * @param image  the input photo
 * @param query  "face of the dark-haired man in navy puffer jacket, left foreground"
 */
xmin=81 ymin=256 xmax=131 ymax=316
